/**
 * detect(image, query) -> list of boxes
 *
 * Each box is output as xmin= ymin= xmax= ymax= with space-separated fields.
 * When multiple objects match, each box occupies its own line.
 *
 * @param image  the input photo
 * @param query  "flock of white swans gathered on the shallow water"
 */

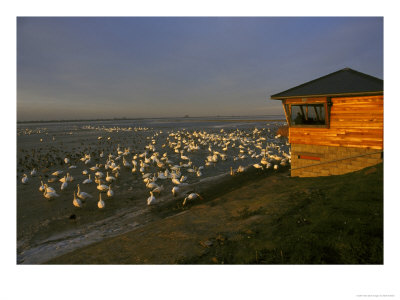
xmin=21 ymin=127 xmax=291 ymax=209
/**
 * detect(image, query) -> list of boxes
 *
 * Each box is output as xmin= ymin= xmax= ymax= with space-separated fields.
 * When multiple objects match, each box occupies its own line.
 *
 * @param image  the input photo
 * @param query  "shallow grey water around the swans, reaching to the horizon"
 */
xmin=17 ymin=116 xmax=290 ymax=263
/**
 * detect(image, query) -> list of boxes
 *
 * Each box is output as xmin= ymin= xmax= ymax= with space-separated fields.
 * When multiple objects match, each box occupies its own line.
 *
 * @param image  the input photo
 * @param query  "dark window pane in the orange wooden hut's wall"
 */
xmin=290 ymin=104 xmax=325 ymax=125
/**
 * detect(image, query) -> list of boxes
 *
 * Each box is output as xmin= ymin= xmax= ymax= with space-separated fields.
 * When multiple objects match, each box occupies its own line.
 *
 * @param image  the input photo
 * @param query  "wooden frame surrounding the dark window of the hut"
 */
xmin=283 ymin=97 xmax=332 ymax=128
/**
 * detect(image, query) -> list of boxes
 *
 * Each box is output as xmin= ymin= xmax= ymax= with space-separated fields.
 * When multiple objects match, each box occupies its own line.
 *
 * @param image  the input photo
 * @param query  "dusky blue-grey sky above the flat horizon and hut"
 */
xmin=17 ymin=17 xmax=383 ymax=121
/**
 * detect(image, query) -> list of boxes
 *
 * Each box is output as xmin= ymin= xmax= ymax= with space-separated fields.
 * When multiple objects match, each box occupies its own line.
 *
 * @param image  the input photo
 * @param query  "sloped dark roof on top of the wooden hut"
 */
xmin=271 ymin=68 xmax=383 ymax=100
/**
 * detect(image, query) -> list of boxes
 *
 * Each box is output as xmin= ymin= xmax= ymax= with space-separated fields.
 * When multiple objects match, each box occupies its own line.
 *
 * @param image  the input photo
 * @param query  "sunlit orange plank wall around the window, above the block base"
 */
xmin=289 ymin=95 xmax=383 ymax=149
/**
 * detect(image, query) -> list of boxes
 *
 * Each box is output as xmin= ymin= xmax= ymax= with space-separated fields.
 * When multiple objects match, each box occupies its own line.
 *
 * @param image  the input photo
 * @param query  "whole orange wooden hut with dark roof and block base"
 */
xmin=271 ymin=68 xmax=383 ymax=177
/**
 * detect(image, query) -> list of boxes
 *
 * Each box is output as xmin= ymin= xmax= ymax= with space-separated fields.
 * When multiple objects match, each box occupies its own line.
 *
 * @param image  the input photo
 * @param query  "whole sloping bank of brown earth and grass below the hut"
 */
xmin=45 ymin=164 xmax=383 ymax=264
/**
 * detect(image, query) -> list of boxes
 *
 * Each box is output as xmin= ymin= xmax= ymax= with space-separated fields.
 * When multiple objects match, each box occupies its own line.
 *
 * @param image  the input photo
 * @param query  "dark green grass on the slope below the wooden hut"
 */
xmin=182 ymin=164 xmax=383 ymax=264
